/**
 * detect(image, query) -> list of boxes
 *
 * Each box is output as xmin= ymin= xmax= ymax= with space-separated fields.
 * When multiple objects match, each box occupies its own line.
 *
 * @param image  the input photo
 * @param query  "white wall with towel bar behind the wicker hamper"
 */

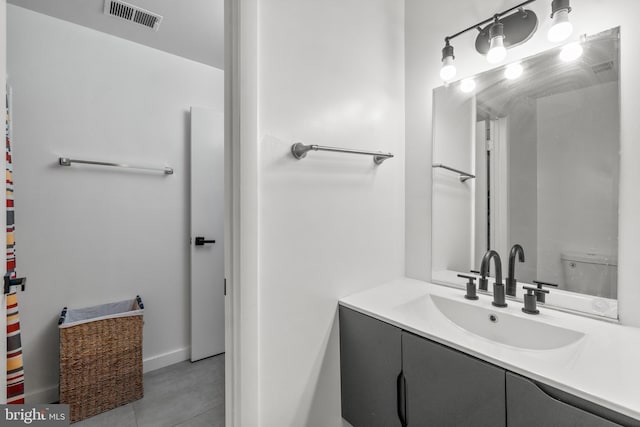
xmin=8 ymin=6 xmax=223 ymax=401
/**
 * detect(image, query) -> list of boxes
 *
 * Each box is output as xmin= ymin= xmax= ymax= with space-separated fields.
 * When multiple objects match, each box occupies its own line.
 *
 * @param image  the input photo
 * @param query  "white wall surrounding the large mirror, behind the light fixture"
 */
xmin=405 ymin=0 xmax=640 ymax=326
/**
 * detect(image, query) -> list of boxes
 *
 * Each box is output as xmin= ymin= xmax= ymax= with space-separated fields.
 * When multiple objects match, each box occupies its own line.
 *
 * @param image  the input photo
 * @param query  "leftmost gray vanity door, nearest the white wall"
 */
xmin=339 ymin=307 xmax=402 ymax=427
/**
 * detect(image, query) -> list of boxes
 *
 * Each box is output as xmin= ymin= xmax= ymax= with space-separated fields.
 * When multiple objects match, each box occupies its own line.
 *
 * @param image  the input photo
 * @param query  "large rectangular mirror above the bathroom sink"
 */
xmin=432 ymin=28 xmax=620 ymax=317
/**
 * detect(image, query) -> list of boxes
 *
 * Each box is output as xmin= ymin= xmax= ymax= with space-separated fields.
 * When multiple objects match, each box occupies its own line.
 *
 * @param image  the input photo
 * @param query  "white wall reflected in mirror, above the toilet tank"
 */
xmin=537 ymin=82 xmax=620 ymax=297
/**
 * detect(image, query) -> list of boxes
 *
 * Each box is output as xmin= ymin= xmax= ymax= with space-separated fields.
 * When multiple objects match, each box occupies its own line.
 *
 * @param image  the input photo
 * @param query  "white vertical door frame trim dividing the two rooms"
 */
xmin=224 ymin=0 xmax=260 ymax=427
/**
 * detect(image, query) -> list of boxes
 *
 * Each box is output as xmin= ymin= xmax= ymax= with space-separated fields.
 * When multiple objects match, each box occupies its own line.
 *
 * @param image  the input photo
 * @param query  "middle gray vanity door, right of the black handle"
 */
xmin=402 ymin=332 xmax=504 ymax=427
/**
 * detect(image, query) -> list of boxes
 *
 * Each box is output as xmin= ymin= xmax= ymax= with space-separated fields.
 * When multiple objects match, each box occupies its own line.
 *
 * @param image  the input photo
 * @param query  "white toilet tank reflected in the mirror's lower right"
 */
xmin=560 ymin=252 xmax=618 ymax=299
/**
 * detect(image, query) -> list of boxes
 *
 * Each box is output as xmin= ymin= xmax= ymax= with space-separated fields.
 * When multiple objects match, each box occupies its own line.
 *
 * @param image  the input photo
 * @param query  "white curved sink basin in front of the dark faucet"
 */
xmin=431 ymin=294 xmax=584 ymax=350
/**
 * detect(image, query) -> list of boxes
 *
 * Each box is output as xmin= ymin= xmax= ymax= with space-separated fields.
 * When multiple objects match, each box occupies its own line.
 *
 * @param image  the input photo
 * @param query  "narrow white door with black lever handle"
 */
xmin=191 ymin=107 xmax=225 ymax=362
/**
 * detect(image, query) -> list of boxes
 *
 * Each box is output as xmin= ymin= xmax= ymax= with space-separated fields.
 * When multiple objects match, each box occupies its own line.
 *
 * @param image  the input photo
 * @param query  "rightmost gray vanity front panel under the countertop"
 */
xmin=507 ymin=372 xmax=640 ymax=427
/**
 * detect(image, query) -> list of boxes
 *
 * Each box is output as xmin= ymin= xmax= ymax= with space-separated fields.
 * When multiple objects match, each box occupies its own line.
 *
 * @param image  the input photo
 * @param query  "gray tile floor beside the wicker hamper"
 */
xmin=72 ymin=354 xmax=224 ymax=427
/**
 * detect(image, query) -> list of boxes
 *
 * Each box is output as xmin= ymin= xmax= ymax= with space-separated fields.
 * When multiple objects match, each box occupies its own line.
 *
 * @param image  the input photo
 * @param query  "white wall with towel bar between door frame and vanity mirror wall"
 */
xmin=239 ymin=0 xmax=404 ymax=427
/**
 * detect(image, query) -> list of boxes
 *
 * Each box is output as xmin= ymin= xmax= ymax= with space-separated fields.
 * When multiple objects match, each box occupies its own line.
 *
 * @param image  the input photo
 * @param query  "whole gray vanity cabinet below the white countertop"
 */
xmin=339 ymin=306 xmax=640 ymax=427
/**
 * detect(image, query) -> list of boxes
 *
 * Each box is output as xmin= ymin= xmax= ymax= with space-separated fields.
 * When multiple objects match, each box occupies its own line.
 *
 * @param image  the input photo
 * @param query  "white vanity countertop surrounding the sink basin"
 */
xmin=340 ymin=278 xmax=640 ymax=420
